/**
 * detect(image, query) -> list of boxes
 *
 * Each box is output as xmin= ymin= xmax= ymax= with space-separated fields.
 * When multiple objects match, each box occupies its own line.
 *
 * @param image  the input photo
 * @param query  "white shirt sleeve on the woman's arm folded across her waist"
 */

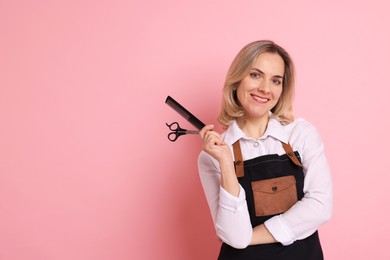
xmin=264 ymin=121 xmax=333 ymax=245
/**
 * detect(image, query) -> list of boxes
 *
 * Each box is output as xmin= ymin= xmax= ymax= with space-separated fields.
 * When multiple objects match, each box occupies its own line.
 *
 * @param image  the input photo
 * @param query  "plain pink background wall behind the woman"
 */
xmin=0 ymin=0 xmax=390 ymax=260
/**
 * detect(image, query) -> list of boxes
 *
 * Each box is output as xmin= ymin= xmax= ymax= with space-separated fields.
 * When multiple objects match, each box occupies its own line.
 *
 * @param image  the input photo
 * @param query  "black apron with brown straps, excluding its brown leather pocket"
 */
xmin=218 ymin=141 xmax=324 ymax=260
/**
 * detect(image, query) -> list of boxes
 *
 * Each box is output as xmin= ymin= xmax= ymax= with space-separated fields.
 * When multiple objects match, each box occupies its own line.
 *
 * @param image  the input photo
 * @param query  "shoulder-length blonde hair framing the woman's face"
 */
xmin=218 ymin=40 xmax=295 ymax=129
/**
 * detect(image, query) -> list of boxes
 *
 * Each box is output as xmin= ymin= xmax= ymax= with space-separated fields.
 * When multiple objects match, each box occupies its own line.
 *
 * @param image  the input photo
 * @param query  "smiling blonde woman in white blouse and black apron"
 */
xmin=198 ymin=41 xmax=332 ymax=260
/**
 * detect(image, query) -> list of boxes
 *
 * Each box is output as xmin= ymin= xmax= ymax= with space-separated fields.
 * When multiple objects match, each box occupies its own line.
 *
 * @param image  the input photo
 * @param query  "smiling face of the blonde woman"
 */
xmin=237 ymin=52 xmax=284 ymax=123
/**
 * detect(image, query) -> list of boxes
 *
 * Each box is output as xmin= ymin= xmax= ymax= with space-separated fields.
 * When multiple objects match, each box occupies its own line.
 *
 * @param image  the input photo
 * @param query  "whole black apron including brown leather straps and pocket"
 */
xmin=218 ymin=140 xmax=323 ymax=260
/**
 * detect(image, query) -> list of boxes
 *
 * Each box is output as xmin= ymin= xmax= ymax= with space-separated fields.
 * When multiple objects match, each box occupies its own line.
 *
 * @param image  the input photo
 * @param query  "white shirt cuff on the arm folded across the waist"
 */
xmin=264 ymin=215 xmax=295 ymax=246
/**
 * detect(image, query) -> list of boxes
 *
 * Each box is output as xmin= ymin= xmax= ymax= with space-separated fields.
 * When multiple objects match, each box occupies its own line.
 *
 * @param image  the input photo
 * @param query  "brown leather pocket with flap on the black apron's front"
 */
xmin=252 ymin=175 xmax=298 ymax=217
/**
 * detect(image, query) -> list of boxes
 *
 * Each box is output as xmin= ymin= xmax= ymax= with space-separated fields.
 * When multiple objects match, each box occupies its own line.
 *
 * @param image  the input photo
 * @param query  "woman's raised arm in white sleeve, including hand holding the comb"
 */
xmin=198 ymin=126 xmax=252 ymax=248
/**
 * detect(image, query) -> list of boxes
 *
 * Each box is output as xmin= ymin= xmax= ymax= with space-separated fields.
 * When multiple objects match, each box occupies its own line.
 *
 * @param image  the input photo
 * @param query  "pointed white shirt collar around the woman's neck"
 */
xmin=224 ymin=118 xmax=288 ymax=145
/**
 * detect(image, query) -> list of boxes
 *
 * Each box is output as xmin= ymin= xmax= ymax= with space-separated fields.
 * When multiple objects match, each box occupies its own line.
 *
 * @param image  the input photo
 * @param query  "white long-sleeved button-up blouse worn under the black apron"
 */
xmin=198 ymin=119 xmax=332 ymax=248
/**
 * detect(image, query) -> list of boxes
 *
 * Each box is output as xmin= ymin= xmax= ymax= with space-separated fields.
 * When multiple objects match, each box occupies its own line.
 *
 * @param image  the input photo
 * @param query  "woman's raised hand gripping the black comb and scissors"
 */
xmin=199 ymin=125 xmax=233 ymax=163
